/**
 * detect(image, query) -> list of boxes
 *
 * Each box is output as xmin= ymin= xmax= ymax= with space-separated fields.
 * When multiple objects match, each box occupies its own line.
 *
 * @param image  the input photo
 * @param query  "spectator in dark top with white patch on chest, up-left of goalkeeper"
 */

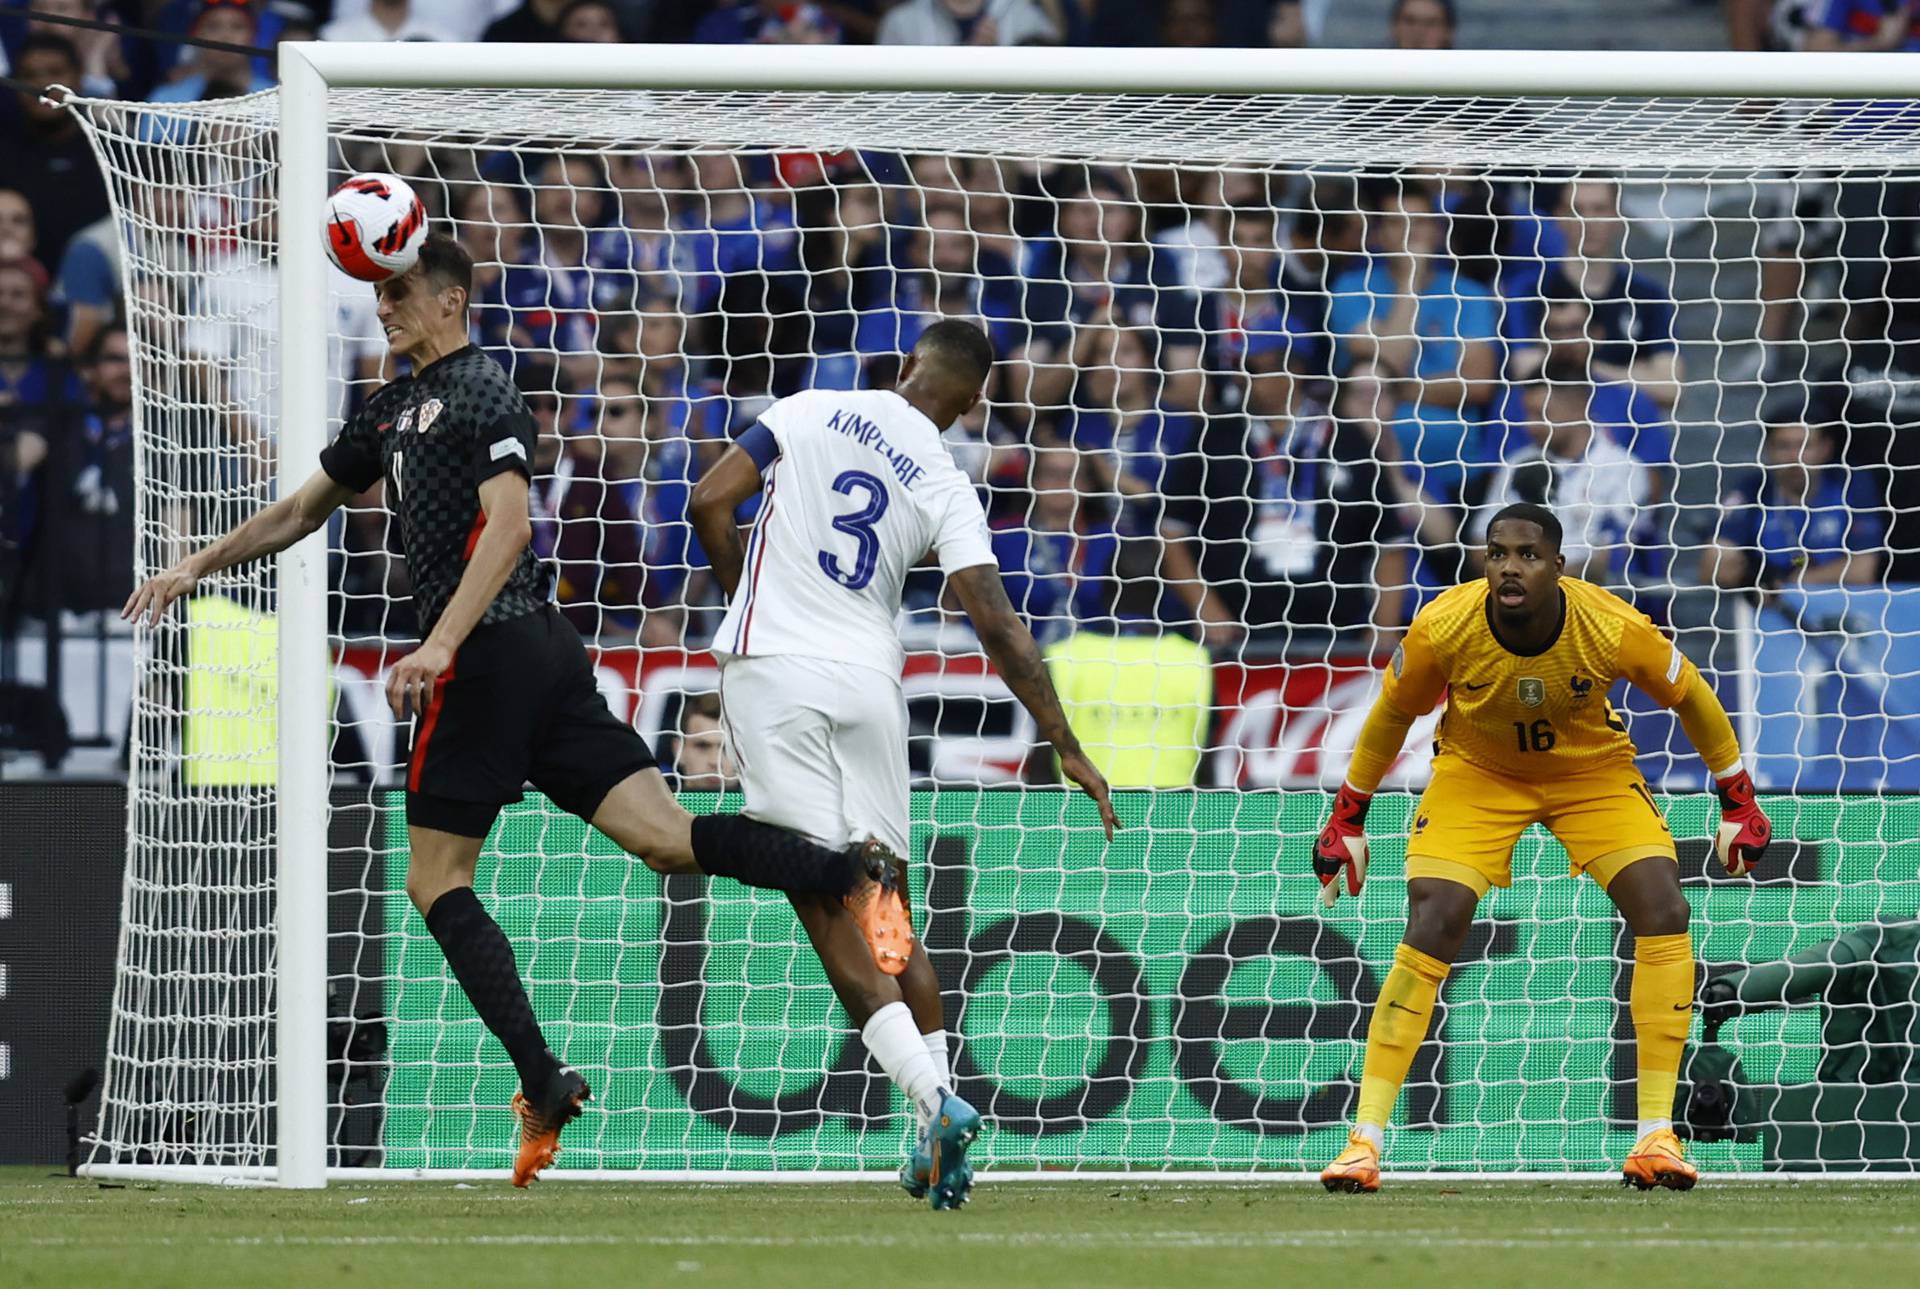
xmin=1198 ymin=330 xmax=1411 ymax=657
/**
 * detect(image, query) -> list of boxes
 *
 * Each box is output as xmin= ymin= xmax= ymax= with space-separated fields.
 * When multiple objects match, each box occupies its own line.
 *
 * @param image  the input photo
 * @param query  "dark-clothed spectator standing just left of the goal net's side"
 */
xmin=60 ymin=327 xmax=134 ymax=613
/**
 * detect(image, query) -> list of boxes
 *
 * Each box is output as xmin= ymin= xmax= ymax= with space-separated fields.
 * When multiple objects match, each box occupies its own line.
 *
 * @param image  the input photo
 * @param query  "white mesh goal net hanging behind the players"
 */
xmin=60 ymin=50 xmax=1920 ymax=1178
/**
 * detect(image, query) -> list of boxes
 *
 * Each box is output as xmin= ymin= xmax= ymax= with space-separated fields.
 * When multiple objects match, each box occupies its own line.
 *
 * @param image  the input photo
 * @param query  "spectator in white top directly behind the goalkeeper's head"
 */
xmin=1467 ymin=369 xmax=1649 ymax=584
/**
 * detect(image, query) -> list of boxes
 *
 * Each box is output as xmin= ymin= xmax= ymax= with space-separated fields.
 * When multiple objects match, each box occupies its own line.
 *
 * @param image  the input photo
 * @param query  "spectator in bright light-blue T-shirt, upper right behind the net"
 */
xmin=1327 ymin=181 xmax=1500 ymax=419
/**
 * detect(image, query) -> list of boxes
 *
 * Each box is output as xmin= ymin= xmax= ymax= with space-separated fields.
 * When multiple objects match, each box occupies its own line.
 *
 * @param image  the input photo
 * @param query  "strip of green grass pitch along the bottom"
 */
xmin=0 ymin=1168 xmax=1920 ymax=1289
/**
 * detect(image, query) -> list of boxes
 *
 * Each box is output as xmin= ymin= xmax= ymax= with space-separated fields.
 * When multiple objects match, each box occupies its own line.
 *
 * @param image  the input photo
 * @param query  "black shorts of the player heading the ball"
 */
xmin=407 ymin=605 xmax=655 ymax=838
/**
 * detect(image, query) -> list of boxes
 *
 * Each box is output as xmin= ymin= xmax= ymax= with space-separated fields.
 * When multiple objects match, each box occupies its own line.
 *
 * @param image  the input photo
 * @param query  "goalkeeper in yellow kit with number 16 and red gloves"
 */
xmin=1313 ymin=503 xmax=1772 ymax=1191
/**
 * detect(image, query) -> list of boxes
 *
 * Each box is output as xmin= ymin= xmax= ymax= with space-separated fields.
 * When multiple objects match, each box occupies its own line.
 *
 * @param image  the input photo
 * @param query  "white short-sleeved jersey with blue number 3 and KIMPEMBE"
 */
xmin=714 ymin=390 xmax=995 ymax=676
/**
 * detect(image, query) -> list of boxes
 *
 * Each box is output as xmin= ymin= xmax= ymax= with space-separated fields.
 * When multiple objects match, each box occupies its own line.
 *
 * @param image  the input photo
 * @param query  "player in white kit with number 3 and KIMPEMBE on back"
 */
xmin=691 ymin=319 xmax=1117 ymax=1208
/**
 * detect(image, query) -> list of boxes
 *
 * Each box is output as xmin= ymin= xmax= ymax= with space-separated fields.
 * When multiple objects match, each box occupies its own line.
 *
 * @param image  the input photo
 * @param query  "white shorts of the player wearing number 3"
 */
xmin=720 ymin=653 xmax=908 ymax=859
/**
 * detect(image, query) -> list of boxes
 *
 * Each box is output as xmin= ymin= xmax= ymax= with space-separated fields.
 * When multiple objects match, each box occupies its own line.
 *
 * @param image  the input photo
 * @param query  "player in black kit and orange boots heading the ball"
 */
xmin=123 ymin=234 xmax=912 ymax=1185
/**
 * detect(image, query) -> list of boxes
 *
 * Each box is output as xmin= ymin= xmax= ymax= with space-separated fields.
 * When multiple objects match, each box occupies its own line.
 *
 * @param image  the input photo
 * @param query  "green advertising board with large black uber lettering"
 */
xmin=384 ymin=790 xmax=1920 ymax=1172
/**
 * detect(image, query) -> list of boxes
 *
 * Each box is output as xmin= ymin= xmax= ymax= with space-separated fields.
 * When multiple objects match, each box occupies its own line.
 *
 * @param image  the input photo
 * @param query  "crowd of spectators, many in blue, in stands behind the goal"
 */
xmin=0 ymin=0 xmax=1920 ymax=691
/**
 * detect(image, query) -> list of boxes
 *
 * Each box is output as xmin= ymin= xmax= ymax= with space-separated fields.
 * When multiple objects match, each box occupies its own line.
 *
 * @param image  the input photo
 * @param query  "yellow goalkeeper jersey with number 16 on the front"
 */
xmin=1384 ymin=578 xmax=1697 ymax=780
